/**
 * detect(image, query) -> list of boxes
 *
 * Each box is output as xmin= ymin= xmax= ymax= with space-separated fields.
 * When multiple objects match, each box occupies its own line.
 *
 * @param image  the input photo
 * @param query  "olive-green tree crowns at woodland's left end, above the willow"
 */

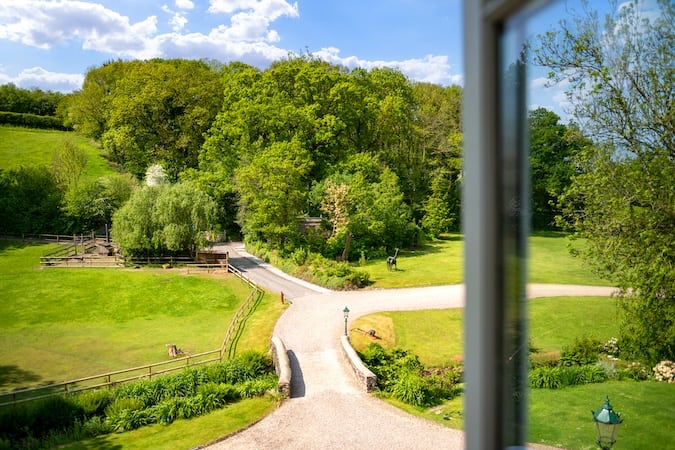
xmin=67 ymin=59 xmax=222 ymax=181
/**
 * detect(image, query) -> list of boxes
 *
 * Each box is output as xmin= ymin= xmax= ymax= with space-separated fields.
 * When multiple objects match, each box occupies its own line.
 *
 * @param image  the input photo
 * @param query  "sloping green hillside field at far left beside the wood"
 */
xmin=0 ymin=126 xmax=116 ymax=178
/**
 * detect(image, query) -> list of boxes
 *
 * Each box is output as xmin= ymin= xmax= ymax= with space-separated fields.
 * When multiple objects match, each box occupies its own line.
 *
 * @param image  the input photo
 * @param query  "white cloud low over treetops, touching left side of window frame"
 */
xmin=312 ymin=47 xmax=464 ymax=85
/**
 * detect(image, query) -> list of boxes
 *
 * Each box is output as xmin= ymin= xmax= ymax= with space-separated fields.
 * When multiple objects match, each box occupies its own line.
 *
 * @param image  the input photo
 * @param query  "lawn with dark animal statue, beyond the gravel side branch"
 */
xmin=361 ymin=232 xmax=612 ymax=288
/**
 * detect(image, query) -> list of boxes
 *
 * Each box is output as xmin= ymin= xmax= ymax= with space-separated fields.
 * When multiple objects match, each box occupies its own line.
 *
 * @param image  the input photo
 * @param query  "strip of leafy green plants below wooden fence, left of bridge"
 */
xmin=0 ymin=352 xmax=276 ymax=445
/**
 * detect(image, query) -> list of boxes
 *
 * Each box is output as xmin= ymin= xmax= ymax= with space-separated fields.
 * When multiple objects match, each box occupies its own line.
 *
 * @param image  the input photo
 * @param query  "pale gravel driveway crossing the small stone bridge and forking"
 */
xmin=207 ymin=243 xmax=614 ymax=450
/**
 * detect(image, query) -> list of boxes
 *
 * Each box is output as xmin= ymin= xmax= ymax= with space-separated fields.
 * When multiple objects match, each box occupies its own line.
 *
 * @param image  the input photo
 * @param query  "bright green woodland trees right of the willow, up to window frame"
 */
xmin=201 ymin=55 xmax=461 ymax=253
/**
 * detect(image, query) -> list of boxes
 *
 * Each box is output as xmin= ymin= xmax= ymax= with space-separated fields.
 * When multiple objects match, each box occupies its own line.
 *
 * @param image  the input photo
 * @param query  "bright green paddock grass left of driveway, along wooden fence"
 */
xmin=0 ymin=242 xmax=283 ymax=391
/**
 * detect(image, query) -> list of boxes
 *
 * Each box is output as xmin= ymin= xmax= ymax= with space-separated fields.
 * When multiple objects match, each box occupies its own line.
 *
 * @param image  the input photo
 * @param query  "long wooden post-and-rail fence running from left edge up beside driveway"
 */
xmin=0 ymin=253 xmax=264 ymax=407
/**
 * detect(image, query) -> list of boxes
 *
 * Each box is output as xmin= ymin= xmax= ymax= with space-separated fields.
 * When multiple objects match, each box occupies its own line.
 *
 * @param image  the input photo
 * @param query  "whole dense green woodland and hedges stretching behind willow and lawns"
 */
xmin=0 ymin=56 xmax=585 ymax=258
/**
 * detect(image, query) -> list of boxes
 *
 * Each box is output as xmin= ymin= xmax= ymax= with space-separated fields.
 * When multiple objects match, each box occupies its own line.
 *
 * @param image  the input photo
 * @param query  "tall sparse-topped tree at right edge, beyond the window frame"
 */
xmin=535 ymin=0 xmax=675 ymax=363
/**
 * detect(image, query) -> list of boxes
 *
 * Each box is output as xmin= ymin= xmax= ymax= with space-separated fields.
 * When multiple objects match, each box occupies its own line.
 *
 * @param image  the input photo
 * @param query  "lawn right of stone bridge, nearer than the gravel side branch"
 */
xmin=351 ymin=297 xmax=675 ymax=449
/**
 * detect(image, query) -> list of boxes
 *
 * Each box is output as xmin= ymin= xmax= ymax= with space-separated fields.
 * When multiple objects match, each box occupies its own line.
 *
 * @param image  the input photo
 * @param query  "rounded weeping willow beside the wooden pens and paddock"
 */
xmin=112 ymin=183 xmax=216 ymax=255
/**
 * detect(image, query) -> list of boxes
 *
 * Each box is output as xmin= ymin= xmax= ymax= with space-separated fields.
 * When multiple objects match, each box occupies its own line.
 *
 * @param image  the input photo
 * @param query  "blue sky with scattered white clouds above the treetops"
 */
xmin=0 ymin=0 xmax=652 ymax=116
